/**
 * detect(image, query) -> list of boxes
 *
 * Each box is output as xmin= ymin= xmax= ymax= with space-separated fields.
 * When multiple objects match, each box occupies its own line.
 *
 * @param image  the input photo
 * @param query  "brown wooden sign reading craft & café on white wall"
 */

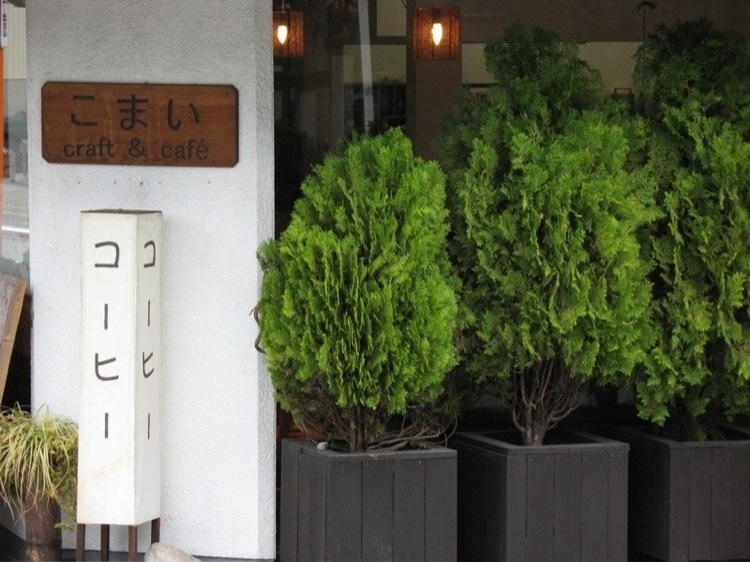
xmin=42 ymin=82 xmax=239 ymax=168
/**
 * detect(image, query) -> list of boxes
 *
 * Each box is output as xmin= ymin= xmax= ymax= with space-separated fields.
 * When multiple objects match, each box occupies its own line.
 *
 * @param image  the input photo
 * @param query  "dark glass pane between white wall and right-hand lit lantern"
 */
xmin=274 ymin=0 xmax=406 ymax=234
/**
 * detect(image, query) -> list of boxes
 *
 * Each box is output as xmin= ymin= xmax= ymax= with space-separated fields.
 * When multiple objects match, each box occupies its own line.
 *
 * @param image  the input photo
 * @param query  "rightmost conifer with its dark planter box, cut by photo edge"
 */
xmin=614 ymin=19 xmax=750 ymax=560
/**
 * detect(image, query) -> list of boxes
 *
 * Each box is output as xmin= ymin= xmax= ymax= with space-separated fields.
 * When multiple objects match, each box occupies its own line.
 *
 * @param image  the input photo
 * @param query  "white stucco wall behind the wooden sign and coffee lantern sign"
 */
xmin=27 ymin=0 xmax=275 ymax=559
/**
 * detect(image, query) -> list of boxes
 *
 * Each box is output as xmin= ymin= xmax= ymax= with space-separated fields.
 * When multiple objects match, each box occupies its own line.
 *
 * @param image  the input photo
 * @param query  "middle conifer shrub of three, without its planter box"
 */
xmin=443 ymin=25 xmax=656 ymax=445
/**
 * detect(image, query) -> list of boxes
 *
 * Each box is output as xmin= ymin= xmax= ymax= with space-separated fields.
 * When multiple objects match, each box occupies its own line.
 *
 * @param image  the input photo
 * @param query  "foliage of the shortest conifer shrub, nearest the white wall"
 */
xmin=258 ymin=129 xmax=456 ymax=450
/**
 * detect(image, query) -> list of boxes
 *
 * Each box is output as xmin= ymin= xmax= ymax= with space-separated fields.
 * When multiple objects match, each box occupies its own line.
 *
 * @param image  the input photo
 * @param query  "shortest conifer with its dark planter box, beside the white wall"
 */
xmin=256 ymin=129 xmax=456 ymax=560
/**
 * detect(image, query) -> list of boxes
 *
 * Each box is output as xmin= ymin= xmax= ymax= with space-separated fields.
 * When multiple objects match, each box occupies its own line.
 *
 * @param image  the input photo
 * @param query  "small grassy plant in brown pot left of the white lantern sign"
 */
xmin=0 ymin=406 xmax=78 ymax=561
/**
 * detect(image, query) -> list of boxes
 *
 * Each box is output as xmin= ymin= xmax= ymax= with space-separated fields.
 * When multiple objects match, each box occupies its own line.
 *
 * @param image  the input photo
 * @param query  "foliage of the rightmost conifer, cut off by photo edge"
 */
xmin=636 ymin=19 xmax=750 ymax=439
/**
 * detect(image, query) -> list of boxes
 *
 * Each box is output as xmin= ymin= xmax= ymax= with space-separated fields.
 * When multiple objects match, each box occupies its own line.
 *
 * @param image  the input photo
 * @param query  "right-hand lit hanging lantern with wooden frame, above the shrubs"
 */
xmin=412 ymin=6 xmax=461 ymax=60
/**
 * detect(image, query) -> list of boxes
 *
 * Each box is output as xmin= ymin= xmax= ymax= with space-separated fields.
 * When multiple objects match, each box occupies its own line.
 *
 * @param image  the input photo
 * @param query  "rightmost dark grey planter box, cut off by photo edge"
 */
xmin=613 ymin=426 xmax=750 ymax=561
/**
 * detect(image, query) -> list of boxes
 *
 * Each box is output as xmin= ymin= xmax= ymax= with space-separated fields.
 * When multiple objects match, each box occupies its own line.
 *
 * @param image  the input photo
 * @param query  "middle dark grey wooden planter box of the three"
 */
xmin=450 ymin=431 xmax=628 ymax=562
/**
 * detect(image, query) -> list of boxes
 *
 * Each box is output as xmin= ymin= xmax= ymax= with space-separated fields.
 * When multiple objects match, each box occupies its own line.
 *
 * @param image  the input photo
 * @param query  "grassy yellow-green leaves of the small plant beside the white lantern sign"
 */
xmin=0 ymin=406 xmax=78 ymax=521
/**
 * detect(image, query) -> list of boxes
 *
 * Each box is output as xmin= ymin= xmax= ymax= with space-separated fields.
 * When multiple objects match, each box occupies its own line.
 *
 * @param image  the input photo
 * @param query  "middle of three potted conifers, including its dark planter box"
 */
xmin=444 ymin=25 xmax=656 ymax=560
